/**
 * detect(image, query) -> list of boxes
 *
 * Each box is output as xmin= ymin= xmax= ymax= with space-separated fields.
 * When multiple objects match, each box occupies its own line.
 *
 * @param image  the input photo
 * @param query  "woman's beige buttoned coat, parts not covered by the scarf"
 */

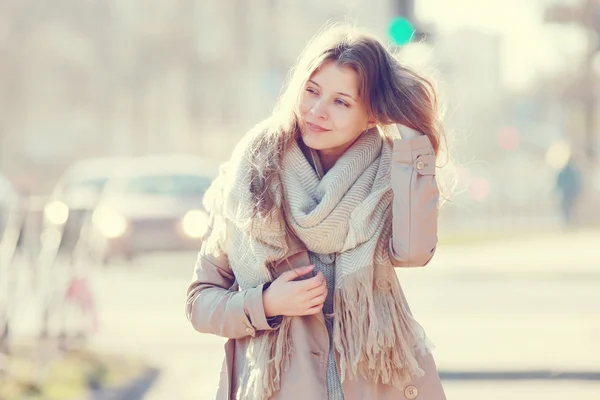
xmin=186 ymin=136 xmax=446 ymax=400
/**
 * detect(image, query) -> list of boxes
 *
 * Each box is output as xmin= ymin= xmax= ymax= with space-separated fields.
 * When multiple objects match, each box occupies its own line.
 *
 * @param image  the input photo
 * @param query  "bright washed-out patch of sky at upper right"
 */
xmin=416 ymin=0 xmax=586 ymax=90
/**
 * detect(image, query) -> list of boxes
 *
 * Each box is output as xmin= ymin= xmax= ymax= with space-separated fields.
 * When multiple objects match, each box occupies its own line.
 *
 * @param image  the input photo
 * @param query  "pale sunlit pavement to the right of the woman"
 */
xmin=398 ymin=230 xmax=600 ymax=400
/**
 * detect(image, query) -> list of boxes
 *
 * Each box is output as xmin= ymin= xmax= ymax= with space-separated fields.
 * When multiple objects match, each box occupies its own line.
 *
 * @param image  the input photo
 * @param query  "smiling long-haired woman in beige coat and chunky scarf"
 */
xmin=187 ymin=23 xmax=445 ymax=400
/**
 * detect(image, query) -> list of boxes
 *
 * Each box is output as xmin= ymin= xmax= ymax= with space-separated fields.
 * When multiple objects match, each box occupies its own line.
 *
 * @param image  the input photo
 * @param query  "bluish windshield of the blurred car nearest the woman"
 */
xmin=125 ymin=175 xmax=211 ymax=197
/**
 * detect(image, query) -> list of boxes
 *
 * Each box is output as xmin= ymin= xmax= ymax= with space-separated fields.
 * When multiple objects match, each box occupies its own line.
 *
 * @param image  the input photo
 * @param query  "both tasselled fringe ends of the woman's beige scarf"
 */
xmin=236 ymin=268 xmax=432 ymax=400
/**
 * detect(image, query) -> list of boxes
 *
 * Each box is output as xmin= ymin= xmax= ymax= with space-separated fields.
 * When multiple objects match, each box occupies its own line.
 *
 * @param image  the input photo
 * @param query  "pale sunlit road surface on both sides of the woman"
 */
xmin=8 ymin=228 xmax=600 ymax=400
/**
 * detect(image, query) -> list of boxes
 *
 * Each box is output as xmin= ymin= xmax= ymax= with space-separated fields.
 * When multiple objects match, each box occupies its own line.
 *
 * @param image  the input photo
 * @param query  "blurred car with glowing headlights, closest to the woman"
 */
xmin=92 ymin=156 xmax=218 ymax=263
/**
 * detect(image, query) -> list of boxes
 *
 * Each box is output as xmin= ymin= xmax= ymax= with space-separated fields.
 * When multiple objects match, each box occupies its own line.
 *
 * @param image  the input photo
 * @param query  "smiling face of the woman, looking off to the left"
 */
xmin=299 ymin=61 xmax=375 ymax=157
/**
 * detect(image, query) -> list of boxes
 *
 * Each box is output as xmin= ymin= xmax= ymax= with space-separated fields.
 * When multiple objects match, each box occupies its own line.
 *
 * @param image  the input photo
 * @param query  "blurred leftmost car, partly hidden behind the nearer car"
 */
xmin=42 ymin=158 xmax=128 ymax=254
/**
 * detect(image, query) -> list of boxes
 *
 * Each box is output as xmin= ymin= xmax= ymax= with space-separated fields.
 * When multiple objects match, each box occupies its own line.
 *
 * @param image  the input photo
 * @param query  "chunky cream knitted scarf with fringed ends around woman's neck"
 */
xmin=205 ymin=128 xmax=426 ymax=399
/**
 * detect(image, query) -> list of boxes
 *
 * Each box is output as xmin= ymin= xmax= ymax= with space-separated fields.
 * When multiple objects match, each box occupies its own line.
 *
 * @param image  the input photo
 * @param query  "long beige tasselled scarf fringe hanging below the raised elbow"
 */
xmin=333 ymin=268 xmax=430 ymax=389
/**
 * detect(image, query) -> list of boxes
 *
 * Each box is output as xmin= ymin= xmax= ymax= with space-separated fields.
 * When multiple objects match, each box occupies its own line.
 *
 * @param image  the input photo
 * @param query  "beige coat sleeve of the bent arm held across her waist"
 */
xmin=186 ymin=230 xmax=281 ymax=339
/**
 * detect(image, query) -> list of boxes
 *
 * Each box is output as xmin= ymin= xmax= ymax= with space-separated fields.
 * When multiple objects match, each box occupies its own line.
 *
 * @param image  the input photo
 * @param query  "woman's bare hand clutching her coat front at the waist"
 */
xmin=263 ymin=265 xmax=327 ymax=318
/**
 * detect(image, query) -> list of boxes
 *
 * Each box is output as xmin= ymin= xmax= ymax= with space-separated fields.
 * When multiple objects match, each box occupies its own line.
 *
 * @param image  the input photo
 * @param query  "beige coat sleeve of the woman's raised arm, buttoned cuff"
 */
xmin=390 ymin=126 xmax=439 ymax=267
